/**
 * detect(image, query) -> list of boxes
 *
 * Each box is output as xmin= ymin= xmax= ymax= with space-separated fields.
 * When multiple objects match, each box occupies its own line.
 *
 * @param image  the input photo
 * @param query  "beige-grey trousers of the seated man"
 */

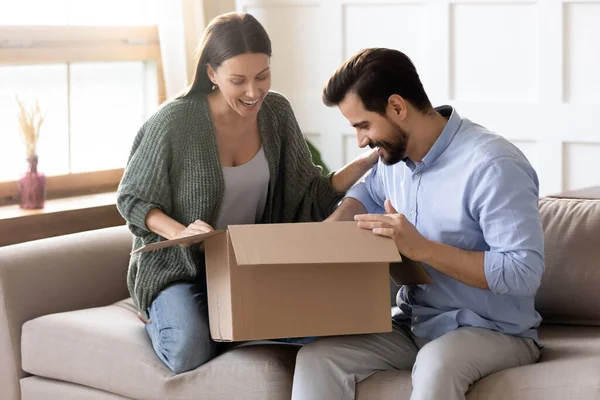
xmin=292 ymin=324 xmax=540 ymax=400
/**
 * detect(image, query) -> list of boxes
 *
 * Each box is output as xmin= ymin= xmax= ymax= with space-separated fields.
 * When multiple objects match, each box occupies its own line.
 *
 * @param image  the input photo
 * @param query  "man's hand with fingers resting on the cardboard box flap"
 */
xmin=354 ymin=200 xmax=430 ymax=261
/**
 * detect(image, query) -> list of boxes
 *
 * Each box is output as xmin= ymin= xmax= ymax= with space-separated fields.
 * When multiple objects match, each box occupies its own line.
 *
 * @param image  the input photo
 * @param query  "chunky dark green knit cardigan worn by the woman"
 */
xmin=117 ymin=92 xmax=343 ymax=316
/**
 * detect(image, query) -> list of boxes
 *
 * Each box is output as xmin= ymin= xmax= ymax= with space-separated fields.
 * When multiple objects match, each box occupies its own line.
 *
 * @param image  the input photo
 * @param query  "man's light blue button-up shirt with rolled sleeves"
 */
xmin=347 ymin=106 xmax=544 ymax=341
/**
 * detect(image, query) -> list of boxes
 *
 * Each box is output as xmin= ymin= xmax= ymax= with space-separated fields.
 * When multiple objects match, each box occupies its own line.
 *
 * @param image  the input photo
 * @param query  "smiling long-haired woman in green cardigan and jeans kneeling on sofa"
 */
xmin=117 ymin=13 xmax=377 ymax=373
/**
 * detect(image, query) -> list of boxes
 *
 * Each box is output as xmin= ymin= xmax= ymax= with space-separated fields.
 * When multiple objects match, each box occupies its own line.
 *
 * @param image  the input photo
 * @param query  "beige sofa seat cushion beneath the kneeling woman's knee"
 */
xmin=21 ymin=300 xmax=297 ymax=400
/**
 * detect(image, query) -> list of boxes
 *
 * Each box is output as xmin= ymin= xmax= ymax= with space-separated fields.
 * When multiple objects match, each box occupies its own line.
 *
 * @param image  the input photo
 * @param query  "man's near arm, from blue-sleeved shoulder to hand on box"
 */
xmin=356 ymin=157 xmax=544 ymax=296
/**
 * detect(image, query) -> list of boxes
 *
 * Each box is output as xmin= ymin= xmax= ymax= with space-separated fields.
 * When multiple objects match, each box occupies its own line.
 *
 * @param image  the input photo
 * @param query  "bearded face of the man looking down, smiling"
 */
xmin=339 ymin=92 xmax=409 ymax=165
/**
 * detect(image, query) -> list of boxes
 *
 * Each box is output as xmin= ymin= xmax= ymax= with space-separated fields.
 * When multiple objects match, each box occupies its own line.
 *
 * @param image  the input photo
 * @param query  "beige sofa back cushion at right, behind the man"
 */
xmin=536 ymin=198 xmax=600 ymax=326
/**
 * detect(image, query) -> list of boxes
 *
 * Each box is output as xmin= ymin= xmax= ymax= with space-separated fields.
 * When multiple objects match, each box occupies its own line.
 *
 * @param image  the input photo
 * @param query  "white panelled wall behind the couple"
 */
xmin=237 ymin=0 xmax=600 ymax=195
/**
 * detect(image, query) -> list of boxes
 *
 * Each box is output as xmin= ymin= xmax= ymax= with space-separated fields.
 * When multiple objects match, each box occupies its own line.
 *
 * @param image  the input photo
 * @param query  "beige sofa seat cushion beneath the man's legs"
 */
xmin=356 ymin=325 xmax=600 ymax=400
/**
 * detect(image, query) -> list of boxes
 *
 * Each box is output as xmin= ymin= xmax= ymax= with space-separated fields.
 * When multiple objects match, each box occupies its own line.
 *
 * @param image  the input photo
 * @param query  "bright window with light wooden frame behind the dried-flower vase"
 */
xmin=0 ymin=0 xmax=165 ymax=205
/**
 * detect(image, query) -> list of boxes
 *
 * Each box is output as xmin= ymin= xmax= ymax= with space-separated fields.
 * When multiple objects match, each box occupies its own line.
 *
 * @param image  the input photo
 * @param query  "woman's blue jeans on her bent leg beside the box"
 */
xmin=146 ymin=282 xmax=316 ymax=374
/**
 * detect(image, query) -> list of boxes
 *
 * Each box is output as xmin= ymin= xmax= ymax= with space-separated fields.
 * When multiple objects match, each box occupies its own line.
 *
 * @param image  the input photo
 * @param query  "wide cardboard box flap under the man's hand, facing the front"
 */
xmin=229 ymin=221 xmax=402 ymax=265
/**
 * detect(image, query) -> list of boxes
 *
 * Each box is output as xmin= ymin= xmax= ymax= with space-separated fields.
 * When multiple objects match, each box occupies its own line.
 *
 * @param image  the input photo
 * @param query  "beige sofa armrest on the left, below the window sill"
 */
xmin=0 ymin=226 xmax=132 ymax=400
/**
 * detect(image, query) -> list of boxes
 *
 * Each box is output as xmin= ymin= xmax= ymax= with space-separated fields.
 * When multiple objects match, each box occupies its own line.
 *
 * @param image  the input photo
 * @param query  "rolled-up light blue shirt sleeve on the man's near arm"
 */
xmin=471 ymin=157 xmax=544 ymax=296
